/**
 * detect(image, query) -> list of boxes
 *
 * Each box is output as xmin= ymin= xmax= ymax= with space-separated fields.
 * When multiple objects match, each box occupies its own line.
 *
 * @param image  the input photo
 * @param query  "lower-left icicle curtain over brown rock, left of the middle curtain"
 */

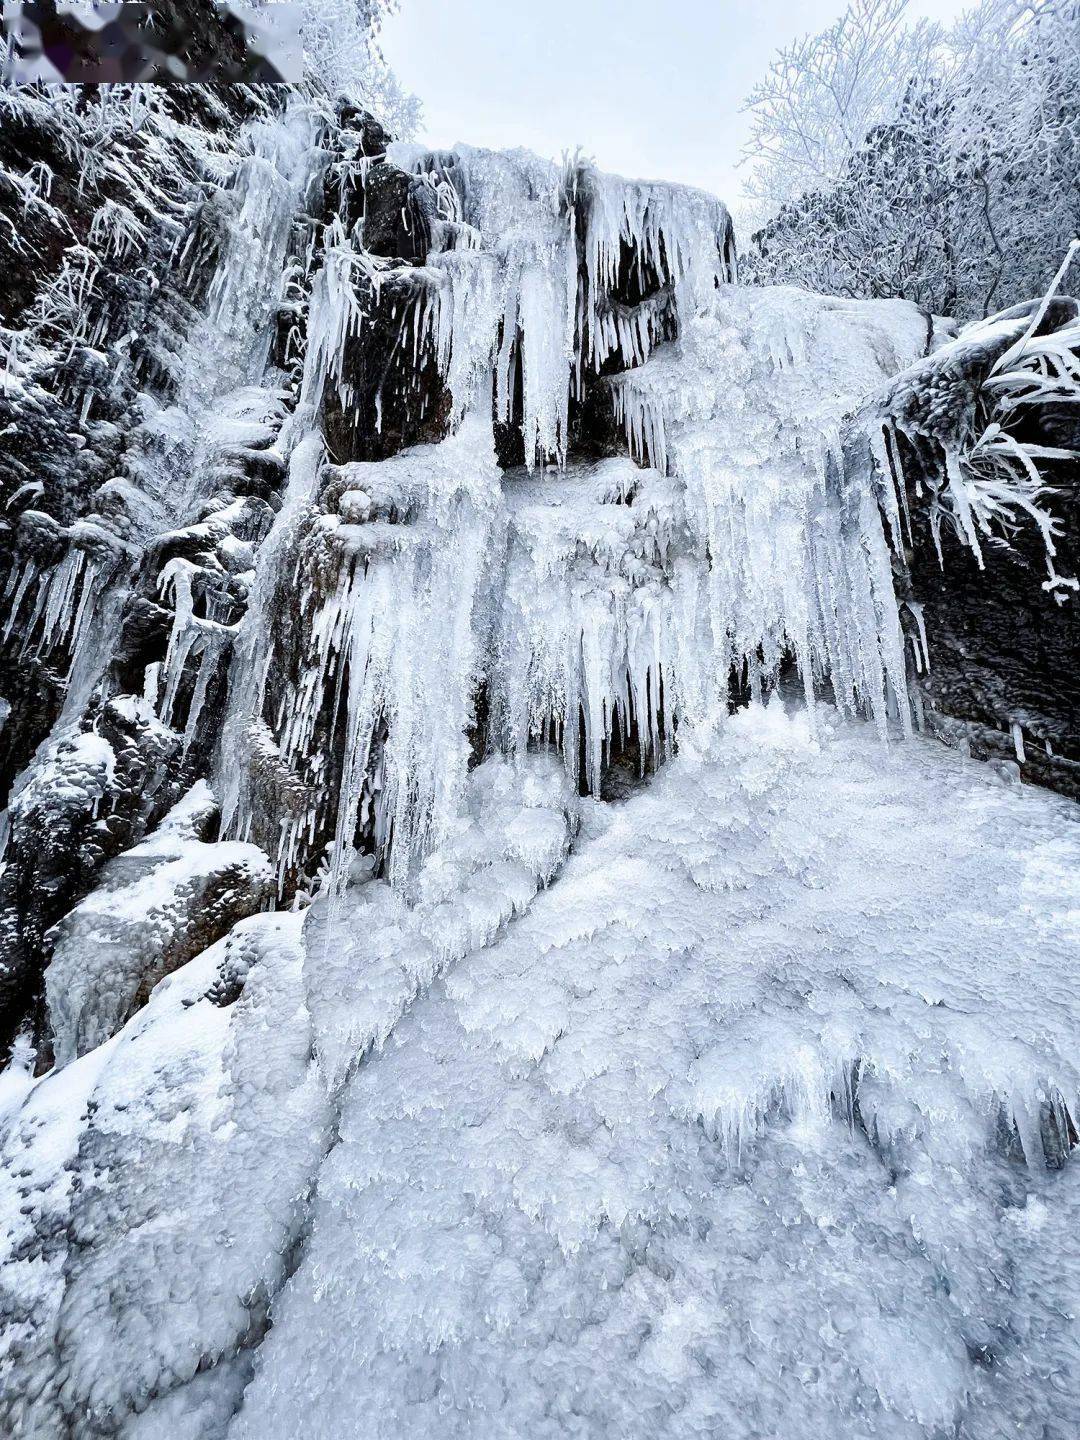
xmin=220 ymin=419 xmax=500 ymax=888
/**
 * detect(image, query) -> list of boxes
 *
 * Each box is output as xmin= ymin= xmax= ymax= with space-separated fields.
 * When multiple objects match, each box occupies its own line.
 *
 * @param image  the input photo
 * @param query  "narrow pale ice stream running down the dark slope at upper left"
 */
xmin=7 ymin=104 xmax=314 ymax=754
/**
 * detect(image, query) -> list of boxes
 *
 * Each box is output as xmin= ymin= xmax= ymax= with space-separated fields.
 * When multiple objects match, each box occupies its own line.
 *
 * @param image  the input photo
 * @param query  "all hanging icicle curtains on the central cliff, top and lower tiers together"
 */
xmin=222 ymin=145 xmax=927 ymax=884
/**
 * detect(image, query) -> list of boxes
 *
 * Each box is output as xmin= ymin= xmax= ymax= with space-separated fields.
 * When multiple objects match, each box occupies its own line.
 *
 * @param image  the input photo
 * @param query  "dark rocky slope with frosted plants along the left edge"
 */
xmin=0 ymin=86 xmax=293 ymax=1056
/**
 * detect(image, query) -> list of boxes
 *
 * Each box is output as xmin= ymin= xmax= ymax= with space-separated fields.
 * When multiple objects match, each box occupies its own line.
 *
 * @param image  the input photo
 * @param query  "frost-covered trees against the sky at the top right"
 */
xmin=747 ymin=0 xmax=1080 ymax=318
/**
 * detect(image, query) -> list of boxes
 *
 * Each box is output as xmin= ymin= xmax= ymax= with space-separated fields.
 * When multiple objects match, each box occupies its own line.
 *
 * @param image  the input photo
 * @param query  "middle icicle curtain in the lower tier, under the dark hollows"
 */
xmin=490 ymin=459 xmax=685 ymax=795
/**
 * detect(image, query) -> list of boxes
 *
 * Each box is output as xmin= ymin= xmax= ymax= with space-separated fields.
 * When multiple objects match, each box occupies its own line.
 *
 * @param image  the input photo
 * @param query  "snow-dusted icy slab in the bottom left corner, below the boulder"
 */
xmin=0 ymin=914 xmax=328 ymax=1440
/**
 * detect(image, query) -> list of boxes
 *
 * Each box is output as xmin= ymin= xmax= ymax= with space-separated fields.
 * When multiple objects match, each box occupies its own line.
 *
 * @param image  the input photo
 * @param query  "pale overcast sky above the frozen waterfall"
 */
xmin=383 ymin=0 xmax=971 ymax=204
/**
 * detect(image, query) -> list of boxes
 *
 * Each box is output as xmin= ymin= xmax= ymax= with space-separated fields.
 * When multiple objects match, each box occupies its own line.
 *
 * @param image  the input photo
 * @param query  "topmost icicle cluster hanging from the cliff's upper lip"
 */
xmin=390 ymin=145 xmax=734 ymax=469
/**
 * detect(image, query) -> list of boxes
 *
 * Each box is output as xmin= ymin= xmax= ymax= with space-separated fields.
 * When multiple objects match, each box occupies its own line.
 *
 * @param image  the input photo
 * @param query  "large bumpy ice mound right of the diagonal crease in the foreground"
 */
xmin=229 ymin=701 xmax=1080 ymax=1440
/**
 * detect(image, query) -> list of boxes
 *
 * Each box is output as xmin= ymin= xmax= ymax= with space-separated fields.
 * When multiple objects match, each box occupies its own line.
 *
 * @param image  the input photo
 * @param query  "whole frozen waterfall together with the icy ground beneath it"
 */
xmin=0 ymin=94 xmax=1080 ymax=1440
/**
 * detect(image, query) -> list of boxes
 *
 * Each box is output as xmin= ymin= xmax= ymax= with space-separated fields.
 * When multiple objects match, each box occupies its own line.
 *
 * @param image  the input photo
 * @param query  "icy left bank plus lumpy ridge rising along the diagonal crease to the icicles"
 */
xmin=0 ymin=756 xmax=577 ymax=1440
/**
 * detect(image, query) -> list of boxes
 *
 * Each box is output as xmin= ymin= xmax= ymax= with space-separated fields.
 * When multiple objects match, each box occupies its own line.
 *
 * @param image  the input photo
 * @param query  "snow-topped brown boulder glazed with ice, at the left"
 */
xmin=45 ymin=782 xmax=274 ymax=1066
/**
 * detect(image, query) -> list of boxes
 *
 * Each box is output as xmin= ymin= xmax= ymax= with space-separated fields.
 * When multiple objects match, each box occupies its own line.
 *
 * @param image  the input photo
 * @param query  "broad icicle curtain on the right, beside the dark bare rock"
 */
xmin=609 ymin=288 xmax=926 ymax=743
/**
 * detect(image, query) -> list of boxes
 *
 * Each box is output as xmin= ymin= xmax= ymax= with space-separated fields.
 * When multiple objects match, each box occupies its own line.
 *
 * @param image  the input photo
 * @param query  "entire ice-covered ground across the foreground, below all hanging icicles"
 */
xmin=0 ymin=700 xmax=1080 ymax=1440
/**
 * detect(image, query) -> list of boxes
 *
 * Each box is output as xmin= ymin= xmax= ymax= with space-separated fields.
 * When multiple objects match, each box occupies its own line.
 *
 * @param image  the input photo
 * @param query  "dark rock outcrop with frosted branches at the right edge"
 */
xmin=886 ymin=297 xmax=1080 ymax=798
